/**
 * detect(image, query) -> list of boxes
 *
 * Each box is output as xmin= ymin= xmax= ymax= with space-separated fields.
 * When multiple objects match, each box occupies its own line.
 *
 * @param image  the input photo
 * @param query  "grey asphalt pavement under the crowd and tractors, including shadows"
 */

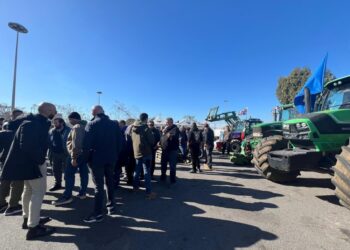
xmin=0 ymin=152 xmax=350 ymax=250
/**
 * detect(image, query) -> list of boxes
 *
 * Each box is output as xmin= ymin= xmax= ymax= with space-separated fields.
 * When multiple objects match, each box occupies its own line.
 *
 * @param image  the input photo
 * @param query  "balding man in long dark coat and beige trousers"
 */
xmin=1 ymin=103 xmax=57 ymax=240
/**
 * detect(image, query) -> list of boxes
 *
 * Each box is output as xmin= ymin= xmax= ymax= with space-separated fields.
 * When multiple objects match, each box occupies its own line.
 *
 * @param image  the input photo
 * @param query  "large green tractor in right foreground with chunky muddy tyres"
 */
xmin=253 ymin=76 xmax=350 ymax=208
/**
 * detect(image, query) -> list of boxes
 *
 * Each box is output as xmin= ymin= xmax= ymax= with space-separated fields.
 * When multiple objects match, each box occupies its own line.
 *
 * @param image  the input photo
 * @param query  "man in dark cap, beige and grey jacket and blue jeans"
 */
xmin=52 ymin=112 xmax=89 ymax=206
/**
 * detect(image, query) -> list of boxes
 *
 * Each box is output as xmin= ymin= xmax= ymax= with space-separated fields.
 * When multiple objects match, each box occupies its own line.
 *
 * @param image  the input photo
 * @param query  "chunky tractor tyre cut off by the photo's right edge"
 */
xmin=332 ymin=142 xmax=350 ymax=209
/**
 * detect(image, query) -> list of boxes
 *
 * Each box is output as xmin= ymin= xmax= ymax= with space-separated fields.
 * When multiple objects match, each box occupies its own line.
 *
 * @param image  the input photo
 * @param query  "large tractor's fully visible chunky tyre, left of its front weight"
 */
xmin=252 ymin=135 xmax=300 ymax=183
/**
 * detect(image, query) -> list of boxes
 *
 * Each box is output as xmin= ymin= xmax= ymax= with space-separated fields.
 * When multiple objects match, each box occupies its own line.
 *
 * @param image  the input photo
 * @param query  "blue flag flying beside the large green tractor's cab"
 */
xmin=294 ymin=54 xmax=328 ymax=114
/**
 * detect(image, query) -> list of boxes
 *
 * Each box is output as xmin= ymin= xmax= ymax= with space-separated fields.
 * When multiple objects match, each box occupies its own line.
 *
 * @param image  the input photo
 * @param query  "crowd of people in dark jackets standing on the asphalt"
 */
xmin=0 ymin=102 xmax=214 ymax=240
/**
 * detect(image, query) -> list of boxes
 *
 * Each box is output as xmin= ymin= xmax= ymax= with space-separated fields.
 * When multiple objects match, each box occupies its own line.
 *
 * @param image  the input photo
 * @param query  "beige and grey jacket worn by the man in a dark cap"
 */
xmin=67 ymin=121 xmax=87 ymax=160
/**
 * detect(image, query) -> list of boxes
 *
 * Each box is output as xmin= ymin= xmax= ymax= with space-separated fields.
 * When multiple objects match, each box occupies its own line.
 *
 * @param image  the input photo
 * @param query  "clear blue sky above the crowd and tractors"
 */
xmin=0 ymin=0 xmax=350 ymax=120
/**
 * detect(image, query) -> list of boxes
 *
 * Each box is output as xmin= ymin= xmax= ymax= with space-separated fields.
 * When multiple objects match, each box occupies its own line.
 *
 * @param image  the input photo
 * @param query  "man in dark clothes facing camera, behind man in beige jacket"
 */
xmin=49 ymin=114 xmax=70 ymax=192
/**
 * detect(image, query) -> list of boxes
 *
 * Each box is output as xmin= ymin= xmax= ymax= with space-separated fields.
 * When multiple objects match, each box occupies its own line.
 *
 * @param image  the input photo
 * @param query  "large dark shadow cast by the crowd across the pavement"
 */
xmin=37 ymin=170 xmax=282 ymax=250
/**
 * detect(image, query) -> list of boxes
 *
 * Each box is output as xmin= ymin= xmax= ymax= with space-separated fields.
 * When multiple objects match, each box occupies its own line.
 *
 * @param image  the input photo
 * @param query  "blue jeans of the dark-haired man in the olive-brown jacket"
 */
xmin=133 ymin=155 xmax=152 ymax=194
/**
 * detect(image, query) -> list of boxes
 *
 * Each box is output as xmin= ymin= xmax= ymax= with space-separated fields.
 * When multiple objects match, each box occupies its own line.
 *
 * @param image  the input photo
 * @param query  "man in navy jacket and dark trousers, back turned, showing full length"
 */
xmin=83 ymin=105 xmax=121 ymax=223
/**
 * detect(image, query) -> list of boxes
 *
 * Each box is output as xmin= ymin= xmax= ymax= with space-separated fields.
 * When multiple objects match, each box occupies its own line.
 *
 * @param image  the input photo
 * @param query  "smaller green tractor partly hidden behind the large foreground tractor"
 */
xmin=230 ymin=104 xmax=296 ymax=165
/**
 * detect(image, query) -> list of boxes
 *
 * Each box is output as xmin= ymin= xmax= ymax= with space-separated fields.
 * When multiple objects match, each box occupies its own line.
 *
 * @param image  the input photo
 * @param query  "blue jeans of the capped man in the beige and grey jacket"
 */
xmin=63 ymin=158 xmax=89 ymax=198
